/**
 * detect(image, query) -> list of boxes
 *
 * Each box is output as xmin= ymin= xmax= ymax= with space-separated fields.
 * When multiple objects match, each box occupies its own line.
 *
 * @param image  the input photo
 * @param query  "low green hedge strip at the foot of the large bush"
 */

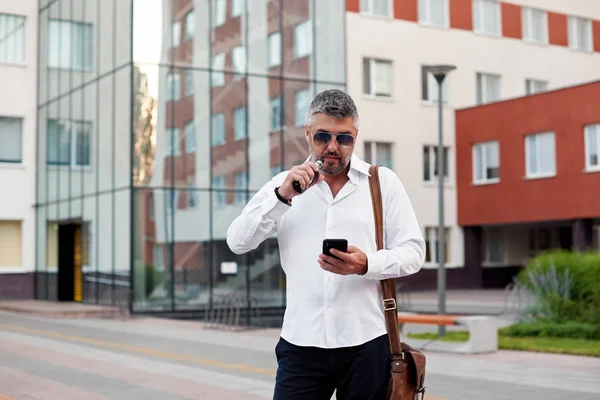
xmin=498 ymin=321 xmax=600 ymax=340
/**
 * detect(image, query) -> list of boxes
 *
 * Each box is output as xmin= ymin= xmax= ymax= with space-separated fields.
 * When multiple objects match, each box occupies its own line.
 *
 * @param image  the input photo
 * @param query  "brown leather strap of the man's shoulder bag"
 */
xmin=369 ymin=165 xmax=402 ymax=355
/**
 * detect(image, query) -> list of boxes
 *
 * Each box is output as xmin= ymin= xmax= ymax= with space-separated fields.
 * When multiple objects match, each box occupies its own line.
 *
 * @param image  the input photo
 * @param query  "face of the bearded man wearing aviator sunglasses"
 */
xmin=306 ymin=113 xmax=358 ymax=175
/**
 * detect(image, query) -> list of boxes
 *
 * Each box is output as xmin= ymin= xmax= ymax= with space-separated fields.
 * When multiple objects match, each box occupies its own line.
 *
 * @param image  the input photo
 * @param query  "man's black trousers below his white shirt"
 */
xmin=273 ymin=335 xmax=391 ymax=400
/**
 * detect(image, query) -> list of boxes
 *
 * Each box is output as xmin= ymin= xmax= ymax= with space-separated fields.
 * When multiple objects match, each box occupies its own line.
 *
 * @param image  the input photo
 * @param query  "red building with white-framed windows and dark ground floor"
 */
xmin=456 ymin=81 xmax=600 ymax=286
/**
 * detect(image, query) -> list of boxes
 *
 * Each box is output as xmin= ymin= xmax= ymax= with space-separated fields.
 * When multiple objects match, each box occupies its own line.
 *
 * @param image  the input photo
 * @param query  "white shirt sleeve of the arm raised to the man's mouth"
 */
xmin=227 ymin=176 xmax=290 ymax=254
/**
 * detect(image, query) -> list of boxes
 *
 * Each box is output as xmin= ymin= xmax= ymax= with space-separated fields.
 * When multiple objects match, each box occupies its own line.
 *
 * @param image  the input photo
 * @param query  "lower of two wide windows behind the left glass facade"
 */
xmin=47 ymin=119 xmax=92 ymax=167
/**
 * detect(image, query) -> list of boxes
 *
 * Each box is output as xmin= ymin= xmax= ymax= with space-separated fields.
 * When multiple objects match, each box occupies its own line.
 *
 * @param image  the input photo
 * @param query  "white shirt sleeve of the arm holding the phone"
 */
xmin=364 ymin=167 xmax=425 ymax=280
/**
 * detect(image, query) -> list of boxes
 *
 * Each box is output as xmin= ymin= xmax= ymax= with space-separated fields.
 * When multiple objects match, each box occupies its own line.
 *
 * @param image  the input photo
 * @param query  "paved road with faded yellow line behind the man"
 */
xmin=0 ymin=311 xmax=600 ymax=400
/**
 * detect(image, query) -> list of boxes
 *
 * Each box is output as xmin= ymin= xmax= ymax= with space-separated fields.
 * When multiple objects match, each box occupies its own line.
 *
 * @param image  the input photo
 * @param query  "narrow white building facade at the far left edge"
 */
xmin=0 ymin=0 xmax=38 ymax=298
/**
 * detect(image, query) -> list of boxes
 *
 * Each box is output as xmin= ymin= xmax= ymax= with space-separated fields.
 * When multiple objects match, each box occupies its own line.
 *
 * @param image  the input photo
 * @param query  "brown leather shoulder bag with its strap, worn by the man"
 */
xmin=369 ymin=165 xmax=425 ymax=400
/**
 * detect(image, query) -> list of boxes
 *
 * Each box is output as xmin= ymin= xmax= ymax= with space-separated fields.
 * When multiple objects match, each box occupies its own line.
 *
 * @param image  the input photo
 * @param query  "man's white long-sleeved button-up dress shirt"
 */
xmin=227 ymin=155 xmax=425 ymax=348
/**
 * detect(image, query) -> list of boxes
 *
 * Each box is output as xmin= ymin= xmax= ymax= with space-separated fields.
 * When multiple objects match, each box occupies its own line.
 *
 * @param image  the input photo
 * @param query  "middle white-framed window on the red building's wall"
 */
xmin=525 ymin=132 xmax=556 ymax=178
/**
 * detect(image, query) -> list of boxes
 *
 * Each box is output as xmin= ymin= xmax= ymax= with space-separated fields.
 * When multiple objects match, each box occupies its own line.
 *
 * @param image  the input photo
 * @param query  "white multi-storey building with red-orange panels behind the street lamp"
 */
xmin=346 ymin=0 xmax=600 ymax=287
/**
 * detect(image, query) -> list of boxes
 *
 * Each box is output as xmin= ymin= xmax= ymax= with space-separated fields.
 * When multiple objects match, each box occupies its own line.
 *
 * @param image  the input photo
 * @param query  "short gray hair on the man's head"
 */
xmin=306 ymin=89 xmax=358 ymax=129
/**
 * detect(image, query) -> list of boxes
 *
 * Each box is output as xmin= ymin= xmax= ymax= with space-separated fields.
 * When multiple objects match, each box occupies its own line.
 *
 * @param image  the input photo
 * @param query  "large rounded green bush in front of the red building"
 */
xmin=517 ymin=250 xmax=600 ymax=324
